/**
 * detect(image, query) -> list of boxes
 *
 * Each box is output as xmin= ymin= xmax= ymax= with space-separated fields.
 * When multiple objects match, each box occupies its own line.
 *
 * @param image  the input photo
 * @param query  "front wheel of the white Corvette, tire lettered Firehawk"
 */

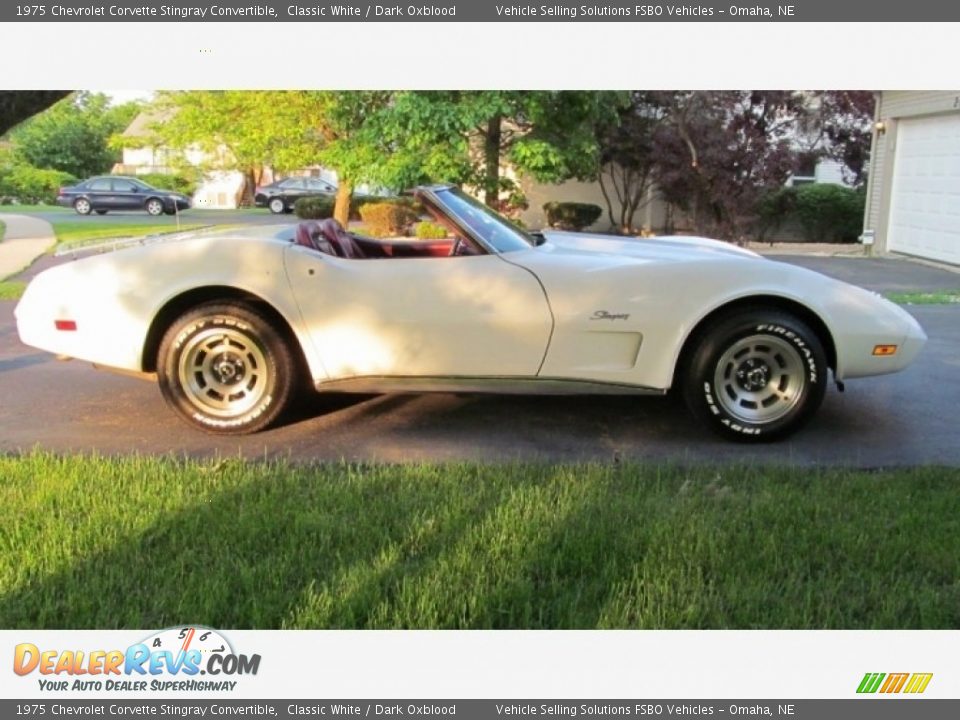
xmin=683 ymin=310 xmax=828 ymax=442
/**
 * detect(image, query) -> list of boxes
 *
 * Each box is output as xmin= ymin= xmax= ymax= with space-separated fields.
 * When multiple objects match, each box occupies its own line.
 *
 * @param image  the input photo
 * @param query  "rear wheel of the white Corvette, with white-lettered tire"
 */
xmin=157 ymin=303 xmax=296 ymax=435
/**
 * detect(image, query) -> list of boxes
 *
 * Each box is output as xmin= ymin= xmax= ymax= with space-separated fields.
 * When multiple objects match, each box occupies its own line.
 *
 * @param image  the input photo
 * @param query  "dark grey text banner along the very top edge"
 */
xmin=0 ymin=0 xmax=960 ymax=22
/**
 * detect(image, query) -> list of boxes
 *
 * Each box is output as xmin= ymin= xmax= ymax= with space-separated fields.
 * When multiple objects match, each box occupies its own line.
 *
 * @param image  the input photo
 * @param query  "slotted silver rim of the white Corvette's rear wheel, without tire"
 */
xmin=178 ymin=328 xmax=270 ymax=418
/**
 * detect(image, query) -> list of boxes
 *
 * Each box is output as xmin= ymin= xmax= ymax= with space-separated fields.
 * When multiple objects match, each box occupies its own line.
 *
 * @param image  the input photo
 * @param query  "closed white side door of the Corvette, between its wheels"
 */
xmin=286 ymin=245 xmax=553 ymax=380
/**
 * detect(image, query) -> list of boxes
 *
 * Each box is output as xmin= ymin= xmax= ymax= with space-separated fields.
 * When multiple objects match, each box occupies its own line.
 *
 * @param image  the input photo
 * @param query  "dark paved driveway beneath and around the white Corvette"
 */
xmin=0 ymin=257 xmax=960 ymax=471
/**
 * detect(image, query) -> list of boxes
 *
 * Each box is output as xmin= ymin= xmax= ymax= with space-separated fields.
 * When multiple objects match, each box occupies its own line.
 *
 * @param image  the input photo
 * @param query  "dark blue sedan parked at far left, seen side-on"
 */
xmin=57 ymin=175 xmax=190 ymax=215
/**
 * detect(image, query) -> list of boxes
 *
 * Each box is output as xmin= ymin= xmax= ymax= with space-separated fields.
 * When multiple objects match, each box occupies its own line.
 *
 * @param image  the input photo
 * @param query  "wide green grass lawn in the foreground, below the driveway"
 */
xmin=0 ymin=453 xmax=960 ymax=628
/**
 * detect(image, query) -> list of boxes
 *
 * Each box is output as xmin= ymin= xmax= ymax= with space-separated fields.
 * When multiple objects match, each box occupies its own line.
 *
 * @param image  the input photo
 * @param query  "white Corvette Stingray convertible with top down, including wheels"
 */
xmin=16 ymin=186 xmax=926 ymax=440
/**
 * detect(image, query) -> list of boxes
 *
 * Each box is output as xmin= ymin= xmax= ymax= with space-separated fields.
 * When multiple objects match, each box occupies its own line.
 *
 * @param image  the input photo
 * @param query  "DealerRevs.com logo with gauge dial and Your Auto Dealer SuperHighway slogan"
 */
xmin=13 ymin=626 xmax=260 ymax=692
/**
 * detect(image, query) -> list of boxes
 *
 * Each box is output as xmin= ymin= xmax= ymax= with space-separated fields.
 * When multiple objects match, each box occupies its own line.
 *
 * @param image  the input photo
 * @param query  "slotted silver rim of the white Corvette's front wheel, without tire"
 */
xmin=713 ymin=335 xmax=807 ymax=425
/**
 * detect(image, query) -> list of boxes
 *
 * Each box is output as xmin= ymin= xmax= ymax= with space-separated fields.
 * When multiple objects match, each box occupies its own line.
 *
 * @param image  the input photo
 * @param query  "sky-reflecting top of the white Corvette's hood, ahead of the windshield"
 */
xmin=542 ymin=230 xmax=761 ymax=262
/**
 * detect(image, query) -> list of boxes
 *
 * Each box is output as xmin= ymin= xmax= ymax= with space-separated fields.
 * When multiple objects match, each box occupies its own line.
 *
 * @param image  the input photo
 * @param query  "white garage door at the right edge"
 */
xmin=887 ymin=115 xmax=960 ymax=265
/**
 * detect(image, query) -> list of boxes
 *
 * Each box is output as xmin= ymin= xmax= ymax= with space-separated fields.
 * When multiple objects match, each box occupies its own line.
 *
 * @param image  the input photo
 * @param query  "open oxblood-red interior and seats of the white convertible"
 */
xmin=293 ymin=218 xmax=480 ymax=260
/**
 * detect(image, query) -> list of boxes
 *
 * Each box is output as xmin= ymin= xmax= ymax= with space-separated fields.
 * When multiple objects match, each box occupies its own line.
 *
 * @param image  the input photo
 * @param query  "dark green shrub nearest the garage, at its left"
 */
xmin=794 ymin=184 xmax=866 ymax=242
